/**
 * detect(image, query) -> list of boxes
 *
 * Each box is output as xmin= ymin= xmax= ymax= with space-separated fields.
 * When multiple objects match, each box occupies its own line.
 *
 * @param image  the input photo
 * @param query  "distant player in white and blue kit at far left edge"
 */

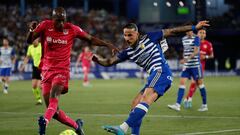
xmin=0 ymin=37 xmax=16 ymax=94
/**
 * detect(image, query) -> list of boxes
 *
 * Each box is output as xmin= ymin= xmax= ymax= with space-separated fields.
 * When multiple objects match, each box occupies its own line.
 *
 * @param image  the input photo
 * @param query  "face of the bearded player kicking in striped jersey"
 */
xmin=123 ymin=28 xmax=139 ymax=46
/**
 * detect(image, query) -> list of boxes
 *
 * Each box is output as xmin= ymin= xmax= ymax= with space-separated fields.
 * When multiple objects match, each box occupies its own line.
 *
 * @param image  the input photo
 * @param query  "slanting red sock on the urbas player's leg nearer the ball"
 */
xmin=53 ymin=110 xmax=78 ymax=129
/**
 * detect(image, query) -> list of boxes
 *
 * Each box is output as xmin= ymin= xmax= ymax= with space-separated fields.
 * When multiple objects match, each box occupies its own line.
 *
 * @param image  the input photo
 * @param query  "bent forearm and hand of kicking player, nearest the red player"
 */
xmin=92 ymin=54 xmax=121 ymax=67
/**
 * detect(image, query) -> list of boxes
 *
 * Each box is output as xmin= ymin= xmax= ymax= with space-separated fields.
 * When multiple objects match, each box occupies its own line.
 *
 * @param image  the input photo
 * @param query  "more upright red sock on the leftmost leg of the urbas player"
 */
xmin=44 ymin=98 xmax=58 ymax=122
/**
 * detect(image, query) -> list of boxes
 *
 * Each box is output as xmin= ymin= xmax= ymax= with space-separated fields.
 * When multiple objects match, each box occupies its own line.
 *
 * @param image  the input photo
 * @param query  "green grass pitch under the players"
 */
xmin=0 ymin=77 xmax=240 ymax=135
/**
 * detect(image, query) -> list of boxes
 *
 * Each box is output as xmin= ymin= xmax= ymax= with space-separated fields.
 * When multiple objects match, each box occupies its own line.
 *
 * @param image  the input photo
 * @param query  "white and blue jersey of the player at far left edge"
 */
xmin=0 ymin=47 xmax=15 ymax=68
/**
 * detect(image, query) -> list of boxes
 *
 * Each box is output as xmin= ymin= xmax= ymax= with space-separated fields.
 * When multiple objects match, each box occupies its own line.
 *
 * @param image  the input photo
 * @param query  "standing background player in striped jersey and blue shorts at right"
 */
xmin=168 ymin=25 xmax=208 ymax=112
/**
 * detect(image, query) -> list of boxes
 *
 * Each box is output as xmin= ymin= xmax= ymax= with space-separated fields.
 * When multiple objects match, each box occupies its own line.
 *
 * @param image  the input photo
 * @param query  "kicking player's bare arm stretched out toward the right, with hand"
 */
xmin=163 ymin=21 xmax=210 ymax=37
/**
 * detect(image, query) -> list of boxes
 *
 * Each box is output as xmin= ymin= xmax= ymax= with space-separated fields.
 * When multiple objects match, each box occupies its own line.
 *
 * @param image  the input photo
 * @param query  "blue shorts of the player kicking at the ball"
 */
xmin=140 ymin=70 xmax=173 ymax=97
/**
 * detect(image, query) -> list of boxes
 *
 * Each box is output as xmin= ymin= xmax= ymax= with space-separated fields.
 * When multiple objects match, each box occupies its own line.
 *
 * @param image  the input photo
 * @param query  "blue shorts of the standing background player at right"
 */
xmin=181 ymin=66 xmax=203 ymax=81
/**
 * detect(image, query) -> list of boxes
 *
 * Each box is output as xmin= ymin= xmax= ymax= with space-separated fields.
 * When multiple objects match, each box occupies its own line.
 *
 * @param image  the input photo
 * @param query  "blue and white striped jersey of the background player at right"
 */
xmin=182 ymin=35 xmax=200 ymax=68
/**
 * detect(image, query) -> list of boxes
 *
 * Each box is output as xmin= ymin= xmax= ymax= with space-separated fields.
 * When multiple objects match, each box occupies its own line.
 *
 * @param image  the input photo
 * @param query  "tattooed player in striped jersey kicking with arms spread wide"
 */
xmin=92 ymin=21 xmax=208 ymax=135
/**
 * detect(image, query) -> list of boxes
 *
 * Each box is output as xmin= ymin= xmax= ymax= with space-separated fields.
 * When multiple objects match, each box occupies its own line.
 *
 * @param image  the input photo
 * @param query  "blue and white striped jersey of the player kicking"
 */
xmin=118 ymin=31 xmax=169 ymax=73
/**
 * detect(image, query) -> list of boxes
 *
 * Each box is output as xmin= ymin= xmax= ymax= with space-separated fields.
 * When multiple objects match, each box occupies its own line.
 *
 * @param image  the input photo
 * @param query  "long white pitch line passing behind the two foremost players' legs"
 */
xmin=0 ymin=112 xmax=240 ymax=119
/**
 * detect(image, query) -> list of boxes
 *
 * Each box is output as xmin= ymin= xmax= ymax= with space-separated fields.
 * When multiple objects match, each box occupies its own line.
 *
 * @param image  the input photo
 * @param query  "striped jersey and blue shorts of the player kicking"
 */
xmin=118 ymin=31 xmax=172 ymax=97
